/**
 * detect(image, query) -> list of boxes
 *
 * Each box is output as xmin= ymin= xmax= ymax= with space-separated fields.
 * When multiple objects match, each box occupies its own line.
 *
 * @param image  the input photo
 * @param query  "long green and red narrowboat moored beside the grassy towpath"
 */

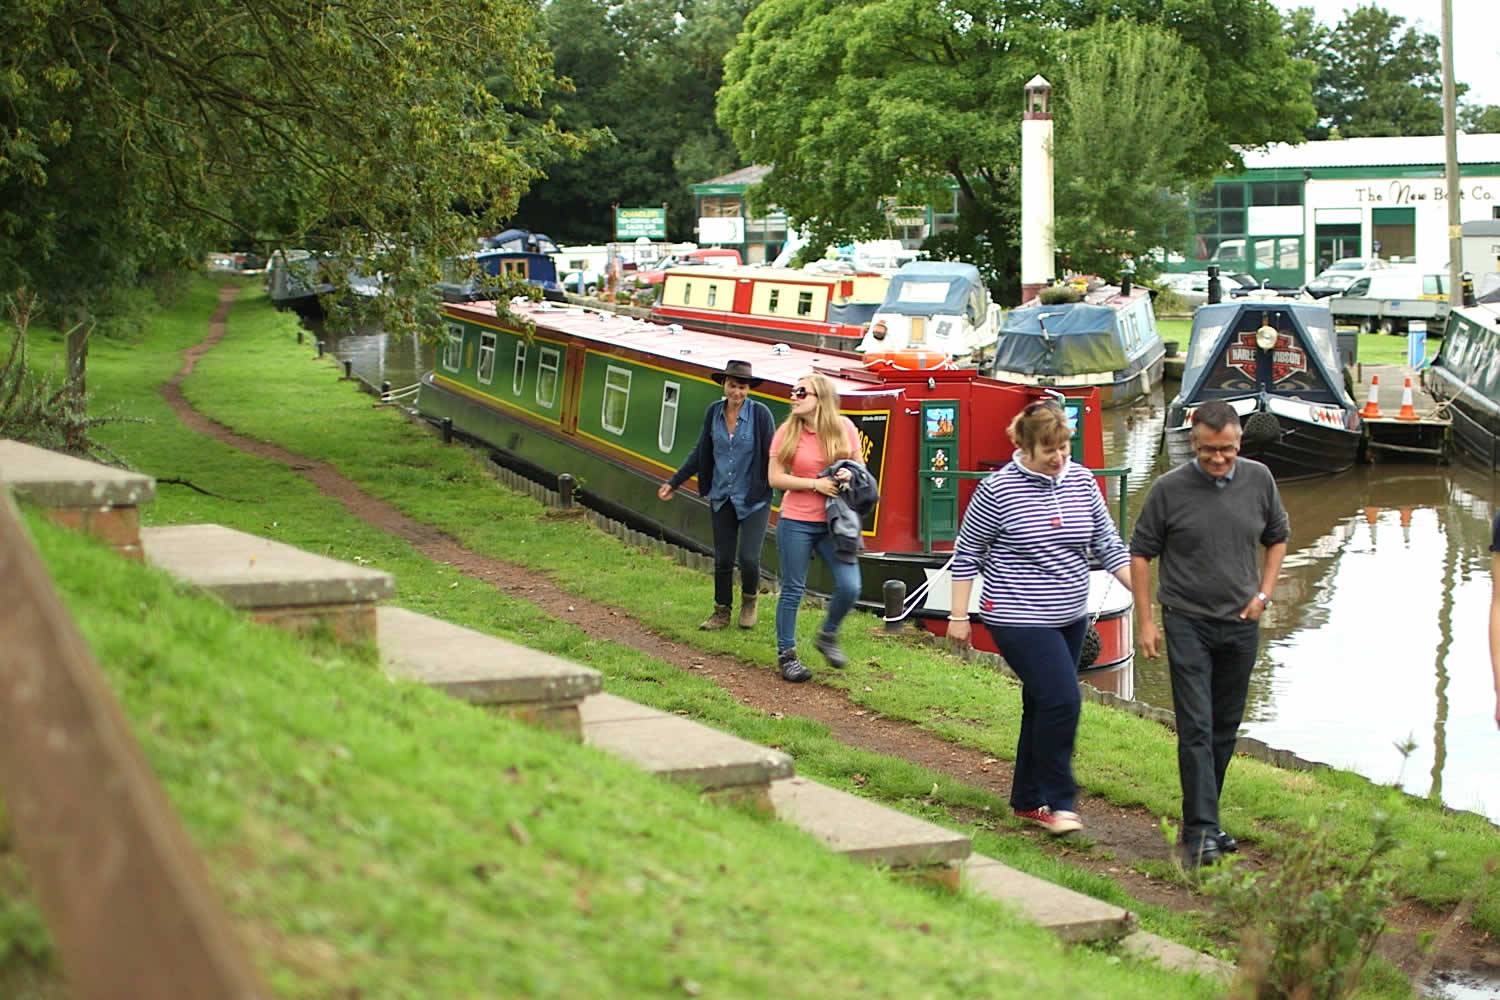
xmin=417 ymin=300 xmax=1133 ymax=675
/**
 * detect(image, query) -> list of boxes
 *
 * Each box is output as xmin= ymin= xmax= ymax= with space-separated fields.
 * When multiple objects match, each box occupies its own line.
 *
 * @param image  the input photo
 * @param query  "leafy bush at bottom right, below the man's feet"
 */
xmin=1206 ymin=814 xmax=1397 ymax=1000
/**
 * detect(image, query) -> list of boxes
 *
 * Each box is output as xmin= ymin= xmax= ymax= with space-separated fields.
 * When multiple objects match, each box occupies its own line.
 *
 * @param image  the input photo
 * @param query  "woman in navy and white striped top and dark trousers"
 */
xmin=948 ymin=400 xmax=1130 ymax=835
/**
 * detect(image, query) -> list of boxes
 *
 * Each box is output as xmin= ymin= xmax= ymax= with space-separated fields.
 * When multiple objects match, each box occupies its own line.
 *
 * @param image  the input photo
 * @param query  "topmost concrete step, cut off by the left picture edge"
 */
xmin=0 ymin=441 xmax=156 ymax=559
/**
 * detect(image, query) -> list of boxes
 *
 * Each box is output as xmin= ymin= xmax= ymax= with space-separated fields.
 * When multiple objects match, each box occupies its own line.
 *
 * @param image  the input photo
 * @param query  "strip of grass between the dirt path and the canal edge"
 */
xmin=167 ymin=281 xmax=1500 ymax=931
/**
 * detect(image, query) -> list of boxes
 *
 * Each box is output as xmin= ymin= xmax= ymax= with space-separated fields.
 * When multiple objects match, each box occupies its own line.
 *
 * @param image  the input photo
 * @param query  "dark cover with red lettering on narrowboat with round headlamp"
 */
xmin=1178 ymin=301 xmax=1353 ymax=405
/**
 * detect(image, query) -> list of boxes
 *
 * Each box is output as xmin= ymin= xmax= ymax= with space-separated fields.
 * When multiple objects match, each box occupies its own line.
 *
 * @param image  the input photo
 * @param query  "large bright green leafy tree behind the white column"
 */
xmin=719 ymin=0 xmax=1313 ymax=297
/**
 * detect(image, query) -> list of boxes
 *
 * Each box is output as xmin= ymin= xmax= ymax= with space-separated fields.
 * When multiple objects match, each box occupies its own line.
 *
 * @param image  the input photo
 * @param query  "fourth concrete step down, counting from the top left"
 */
xmin=579 ymin=694 xmax=792 ymax=811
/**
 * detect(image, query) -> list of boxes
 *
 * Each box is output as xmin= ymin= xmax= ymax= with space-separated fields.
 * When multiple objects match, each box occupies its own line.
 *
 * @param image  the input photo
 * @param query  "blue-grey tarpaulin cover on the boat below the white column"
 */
xmin=995 ymin=303 xmax=1130 ymax=375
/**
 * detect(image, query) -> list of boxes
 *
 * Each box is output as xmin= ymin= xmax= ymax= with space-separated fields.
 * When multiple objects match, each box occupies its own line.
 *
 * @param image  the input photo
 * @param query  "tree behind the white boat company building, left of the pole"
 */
xmin=1287 ymin=3 xmax=1467 ymax=139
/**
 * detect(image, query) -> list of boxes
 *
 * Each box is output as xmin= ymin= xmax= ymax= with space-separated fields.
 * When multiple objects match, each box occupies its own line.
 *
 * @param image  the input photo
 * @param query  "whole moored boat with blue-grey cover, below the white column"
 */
xmin=990 ymin=285 xmax=1167 ymax=406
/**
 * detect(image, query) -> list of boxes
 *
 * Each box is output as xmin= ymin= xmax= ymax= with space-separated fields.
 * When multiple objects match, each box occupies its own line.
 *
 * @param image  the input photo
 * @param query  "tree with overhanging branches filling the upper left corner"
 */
xmin=0 ymin=0 xmax=579 ymax=328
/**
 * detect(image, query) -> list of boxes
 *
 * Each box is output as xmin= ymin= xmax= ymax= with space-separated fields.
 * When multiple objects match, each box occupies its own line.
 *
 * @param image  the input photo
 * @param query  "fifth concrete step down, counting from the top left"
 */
xmin=771 ymin=778 xmax=971 ymax=889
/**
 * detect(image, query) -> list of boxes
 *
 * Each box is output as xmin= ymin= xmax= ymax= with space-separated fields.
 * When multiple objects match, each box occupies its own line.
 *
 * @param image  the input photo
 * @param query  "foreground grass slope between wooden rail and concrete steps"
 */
xmin=17 ymin=519 xmax=1212 ymax=997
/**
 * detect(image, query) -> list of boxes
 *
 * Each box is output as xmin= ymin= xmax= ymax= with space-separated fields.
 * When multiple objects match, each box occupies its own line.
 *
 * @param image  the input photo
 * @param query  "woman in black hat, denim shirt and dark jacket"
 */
xmin=657 ymin=361 xmax=776 ymax=631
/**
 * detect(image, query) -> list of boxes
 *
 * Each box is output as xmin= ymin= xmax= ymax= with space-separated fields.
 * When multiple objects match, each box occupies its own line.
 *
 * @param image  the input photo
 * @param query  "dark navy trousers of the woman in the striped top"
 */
xmin=986 ymin=618 xmax=1089 ymax=813
